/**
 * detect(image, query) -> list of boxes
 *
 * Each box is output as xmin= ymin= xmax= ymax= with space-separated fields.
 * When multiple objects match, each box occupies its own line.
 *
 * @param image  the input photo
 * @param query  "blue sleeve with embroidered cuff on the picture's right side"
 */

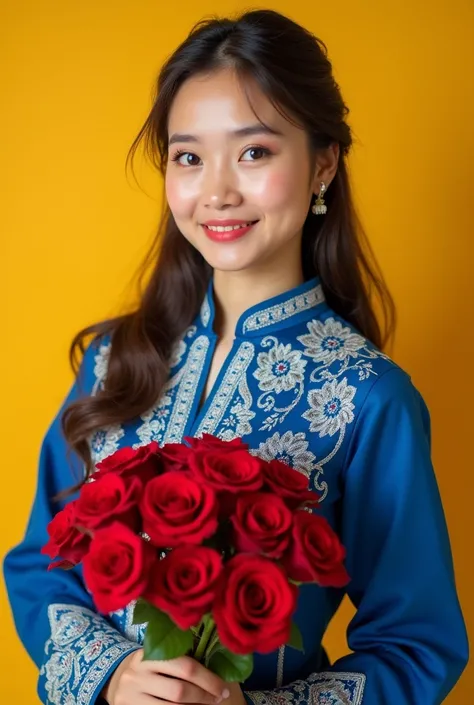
xmin=246 ymin=367 xmax=468 ymax=705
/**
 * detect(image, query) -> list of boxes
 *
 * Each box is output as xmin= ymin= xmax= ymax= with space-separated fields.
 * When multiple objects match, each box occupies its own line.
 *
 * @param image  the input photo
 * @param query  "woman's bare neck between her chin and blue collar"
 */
xmin=213 ymin=267 xmax=304 ymax=343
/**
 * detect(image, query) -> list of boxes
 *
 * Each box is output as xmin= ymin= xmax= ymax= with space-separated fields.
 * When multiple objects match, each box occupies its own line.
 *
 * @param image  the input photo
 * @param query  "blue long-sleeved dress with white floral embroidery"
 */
xmin=4 ymin=279 xmax=468 ymax=705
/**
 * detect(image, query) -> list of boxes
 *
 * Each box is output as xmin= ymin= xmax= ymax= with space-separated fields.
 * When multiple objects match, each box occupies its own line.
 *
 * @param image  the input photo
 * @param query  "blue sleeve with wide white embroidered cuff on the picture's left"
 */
xmin=3 ymin=338 xmax=138 ymax=705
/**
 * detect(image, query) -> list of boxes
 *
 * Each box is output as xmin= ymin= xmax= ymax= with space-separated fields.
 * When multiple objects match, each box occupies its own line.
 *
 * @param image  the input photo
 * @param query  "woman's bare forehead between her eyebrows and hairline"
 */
xmin=168 ymin=68 xmax=295 ymax=139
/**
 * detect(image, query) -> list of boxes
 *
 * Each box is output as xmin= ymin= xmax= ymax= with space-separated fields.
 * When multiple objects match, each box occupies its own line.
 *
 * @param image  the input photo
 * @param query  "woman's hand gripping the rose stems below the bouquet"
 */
xmin=102 ymin=649 xmax=231 ymax=705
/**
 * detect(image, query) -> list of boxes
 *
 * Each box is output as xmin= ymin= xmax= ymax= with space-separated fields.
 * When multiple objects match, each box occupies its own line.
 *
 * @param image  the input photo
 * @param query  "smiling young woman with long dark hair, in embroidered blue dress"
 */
xmin=4 ymin=6 xmax=467 ymax=705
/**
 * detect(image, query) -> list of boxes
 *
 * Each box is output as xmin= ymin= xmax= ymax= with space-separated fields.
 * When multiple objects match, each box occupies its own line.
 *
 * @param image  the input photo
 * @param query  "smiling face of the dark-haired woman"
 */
xmin=166 ymin=69 xmax=320 ymax=273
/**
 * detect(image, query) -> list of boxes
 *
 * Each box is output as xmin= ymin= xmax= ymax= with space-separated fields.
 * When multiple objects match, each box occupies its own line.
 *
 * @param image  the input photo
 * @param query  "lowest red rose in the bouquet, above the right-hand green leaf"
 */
xmin=213 ymin=555 xmax=298 ymax=654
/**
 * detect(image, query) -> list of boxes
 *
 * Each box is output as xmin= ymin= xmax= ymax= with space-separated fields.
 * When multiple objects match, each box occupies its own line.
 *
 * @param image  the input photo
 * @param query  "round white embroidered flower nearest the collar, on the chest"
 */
xmin=253 ymin=343 xmax=307 ymax=394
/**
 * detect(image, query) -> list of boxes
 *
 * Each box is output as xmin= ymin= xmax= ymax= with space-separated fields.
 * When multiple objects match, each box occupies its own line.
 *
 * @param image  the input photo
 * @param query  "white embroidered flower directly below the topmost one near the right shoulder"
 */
xmin=302 ymin=377 xmax=357 ymax=437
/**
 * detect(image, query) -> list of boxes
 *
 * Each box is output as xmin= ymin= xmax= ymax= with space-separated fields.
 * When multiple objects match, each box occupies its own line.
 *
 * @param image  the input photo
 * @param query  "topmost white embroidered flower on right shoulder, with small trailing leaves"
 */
xmin=297 ymin=318 xmax=391 ymax=382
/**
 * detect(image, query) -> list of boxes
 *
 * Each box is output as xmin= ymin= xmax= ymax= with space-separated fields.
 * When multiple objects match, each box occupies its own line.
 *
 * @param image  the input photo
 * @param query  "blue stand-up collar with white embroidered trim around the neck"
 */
xmin=197 ymin=277 xmax=325 ymax=338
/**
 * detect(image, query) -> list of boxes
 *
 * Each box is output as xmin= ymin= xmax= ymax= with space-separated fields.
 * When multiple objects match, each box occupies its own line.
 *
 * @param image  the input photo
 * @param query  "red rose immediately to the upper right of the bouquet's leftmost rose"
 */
xmin=76 ymin=472 xmax=142 ymax=531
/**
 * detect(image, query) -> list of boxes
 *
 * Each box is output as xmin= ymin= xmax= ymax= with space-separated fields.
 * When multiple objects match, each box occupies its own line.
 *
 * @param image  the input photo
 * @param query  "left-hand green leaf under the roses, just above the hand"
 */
xmin=143 ymin=610 xmax=193 ymax=661
